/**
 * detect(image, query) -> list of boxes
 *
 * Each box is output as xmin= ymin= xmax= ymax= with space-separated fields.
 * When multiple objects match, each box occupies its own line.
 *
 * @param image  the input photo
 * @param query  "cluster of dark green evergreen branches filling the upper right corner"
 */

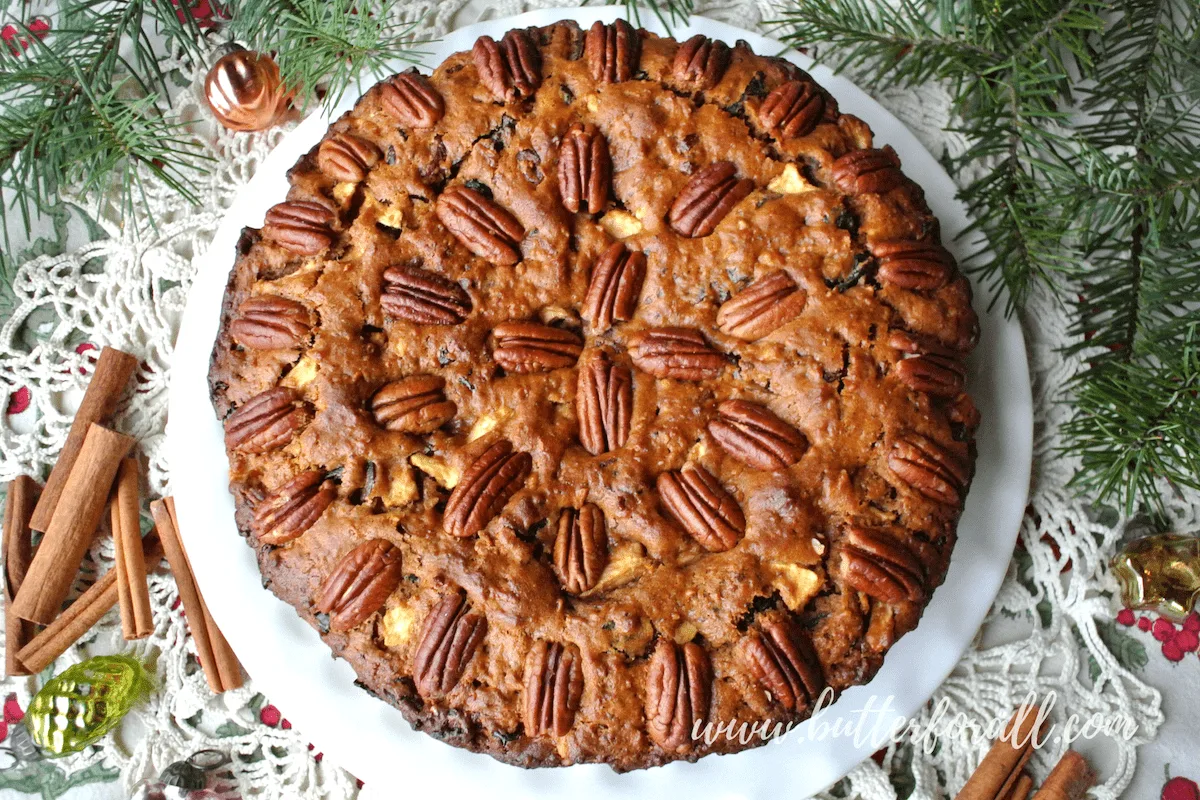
xmin=778 ymin=0 xmax=1200 ymax=511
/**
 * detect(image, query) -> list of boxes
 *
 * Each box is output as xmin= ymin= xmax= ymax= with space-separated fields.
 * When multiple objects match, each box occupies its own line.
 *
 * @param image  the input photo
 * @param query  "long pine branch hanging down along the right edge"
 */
xmin=1063 ymin=0 xmax=1200 ymax=511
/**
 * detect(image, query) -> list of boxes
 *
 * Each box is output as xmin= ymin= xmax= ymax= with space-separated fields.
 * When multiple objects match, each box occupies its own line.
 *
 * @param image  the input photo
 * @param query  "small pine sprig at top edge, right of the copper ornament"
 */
xmin=229 ymin=0 xmax=424 ymax=109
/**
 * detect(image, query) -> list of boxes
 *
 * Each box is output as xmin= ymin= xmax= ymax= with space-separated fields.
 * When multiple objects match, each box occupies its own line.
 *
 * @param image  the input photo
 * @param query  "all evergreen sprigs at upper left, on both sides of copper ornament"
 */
xmin=0 ymin=0 xmax=429 ymax=247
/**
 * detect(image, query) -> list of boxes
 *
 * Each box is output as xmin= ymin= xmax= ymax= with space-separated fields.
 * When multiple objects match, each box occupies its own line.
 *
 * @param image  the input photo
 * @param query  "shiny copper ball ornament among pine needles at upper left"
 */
xmin=204 ymin=47 xmax=292 ymax=131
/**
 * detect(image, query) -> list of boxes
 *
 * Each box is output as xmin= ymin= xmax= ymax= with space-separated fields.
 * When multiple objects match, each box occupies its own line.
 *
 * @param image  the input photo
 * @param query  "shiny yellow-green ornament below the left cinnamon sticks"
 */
xmin=25 ymin=656 xmax=154 ymax=756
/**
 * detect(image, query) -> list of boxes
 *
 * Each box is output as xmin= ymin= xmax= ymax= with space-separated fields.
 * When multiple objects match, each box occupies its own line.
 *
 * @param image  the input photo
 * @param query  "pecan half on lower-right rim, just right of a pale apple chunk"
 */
xmin=841 ymin=528 xmax=925 ymax=603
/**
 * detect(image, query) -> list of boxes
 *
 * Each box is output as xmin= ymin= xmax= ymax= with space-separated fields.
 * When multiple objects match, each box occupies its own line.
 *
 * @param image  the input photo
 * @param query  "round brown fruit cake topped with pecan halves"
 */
xmin=210 ymin=22 xmax=978 ymax=770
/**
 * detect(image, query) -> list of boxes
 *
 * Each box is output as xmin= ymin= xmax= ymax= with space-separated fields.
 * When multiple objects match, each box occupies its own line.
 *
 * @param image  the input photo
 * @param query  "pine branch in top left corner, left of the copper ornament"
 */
xmin=0 ymin=0 xmax=211 ymax=241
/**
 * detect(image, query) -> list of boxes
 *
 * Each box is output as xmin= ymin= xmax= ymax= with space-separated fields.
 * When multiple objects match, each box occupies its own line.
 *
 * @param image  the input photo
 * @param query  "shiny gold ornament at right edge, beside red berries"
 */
xmin=1112 ymin=534 xmax=1200 ymax=621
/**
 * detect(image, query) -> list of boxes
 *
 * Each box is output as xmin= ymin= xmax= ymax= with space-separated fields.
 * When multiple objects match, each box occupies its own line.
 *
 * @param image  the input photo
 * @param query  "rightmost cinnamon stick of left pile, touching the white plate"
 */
xmin=150 ymin=498 xmax=242 ymax=694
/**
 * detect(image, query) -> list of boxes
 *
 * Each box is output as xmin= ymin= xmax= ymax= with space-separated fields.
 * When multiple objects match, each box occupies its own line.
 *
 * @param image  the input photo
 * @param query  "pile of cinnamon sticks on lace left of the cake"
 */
xmin=2 ymin=347 xmax=241 ymax=692
